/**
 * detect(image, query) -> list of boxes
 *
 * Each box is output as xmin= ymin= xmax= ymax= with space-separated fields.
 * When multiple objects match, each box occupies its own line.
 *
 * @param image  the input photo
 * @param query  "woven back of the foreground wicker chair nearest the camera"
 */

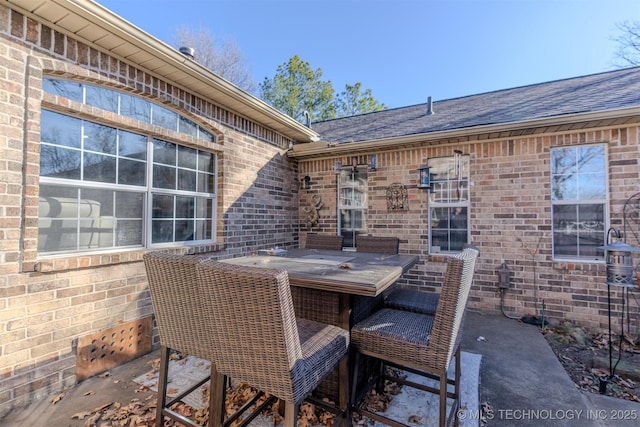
xmin=198 ymin=261 xmax=302 ymax=401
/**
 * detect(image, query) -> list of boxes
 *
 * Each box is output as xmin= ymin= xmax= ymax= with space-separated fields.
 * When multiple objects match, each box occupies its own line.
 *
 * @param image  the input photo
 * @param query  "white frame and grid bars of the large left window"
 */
xmin=38 ymin=79 xmax=218 ymax=257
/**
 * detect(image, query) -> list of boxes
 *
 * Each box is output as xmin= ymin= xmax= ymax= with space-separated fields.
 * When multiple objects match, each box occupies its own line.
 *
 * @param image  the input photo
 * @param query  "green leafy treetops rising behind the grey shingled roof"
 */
xmin=259 ymin=55 xmax=386 ymax=123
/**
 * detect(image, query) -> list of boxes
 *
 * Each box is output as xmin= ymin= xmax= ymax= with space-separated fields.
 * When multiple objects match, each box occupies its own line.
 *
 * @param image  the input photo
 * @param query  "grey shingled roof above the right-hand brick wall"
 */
xmin=312 ymin=67 xmax=640 ymax=143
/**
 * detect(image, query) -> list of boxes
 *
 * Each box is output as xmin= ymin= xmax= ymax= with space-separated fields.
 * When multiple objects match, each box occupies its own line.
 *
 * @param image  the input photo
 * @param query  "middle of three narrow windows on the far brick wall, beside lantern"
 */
xmin=427 ymin=154 xmax=469 ymax=253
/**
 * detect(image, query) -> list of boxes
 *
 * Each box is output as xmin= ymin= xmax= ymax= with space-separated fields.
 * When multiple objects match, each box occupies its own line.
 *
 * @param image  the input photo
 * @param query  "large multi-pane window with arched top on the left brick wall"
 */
xmin=38 ymin=80 xmax=216 ymax=255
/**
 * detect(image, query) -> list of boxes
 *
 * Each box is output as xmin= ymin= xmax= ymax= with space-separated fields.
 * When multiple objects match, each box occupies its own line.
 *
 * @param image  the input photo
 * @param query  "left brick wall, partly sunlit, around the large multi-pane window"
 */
xmin=0 ymin=7 xmax=298 ymax=417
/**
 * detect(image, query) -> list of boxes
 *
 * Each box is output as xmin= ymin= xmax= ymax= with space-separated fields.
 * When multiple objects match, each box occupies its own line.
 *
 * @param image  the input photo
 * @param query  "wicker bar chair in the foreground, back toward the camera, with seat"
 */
xmin=197 ymin=260 xmax=349 ymax=426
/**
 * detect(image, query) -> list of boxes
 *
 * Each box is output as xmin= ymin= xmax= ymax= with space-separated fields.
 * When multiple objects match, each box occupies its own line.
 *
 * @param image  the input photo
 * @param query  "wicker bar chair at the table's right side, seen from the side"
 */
xmin=351 ymin=248 xmax=478 ymax=426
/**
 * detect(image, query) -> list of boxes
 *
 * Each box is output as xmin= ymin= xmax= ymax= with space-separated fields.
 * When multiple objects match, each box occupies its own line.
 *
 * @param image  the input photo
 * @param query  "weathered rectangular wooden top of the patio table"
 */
xmin=224 ymin=249 xmax=418 ymax=297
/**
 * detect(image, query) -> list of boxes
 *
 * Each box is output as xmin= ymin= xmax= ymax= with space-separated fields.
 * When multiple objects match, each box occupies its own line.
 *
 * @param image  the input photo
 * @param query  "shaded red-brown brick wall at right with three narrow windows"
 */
xmin=299 ymin=127 xmax=640 ymax=330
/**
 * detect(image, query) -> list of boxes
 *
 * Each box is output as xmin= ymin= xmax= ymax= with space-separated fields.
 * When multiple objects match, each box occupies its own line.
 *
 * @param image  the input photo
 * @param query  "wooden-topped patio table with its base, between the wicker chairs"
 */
xmin=223 ymin=249 xmax=418 ymax=401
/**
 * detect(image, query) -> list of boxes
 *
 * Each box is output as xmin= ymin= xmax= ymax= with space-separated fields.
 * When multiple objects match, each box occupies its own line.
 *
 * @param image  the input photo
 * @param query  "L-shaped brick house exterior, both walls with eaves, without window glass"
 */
xmin=0 ymin=0 xmax=640 ymax=418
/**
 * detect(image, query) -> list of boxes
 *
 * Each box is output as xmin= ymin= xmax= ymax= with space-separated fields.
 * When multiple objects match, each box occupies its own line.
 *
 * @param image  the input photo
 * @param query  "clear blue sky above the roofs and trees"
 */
xmin=98 ymin=0 xmax=640 ymax=108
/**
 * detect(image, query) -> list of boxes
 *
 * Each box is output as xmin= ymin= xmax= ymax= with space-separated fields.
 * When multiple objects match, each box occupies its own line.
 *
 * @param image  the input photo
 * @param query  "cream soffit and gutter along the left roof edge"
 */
xmin=0 ymin=0 xmax=318 ymax=142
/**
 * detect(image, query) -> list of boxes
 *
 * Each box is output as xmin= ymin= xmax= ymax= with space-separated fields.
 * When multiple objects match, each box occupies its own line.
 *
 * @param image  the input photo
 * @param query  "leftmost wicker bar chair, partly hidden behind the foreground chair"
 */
xmin=143 ymin=252 xmax=225 ymax=427
